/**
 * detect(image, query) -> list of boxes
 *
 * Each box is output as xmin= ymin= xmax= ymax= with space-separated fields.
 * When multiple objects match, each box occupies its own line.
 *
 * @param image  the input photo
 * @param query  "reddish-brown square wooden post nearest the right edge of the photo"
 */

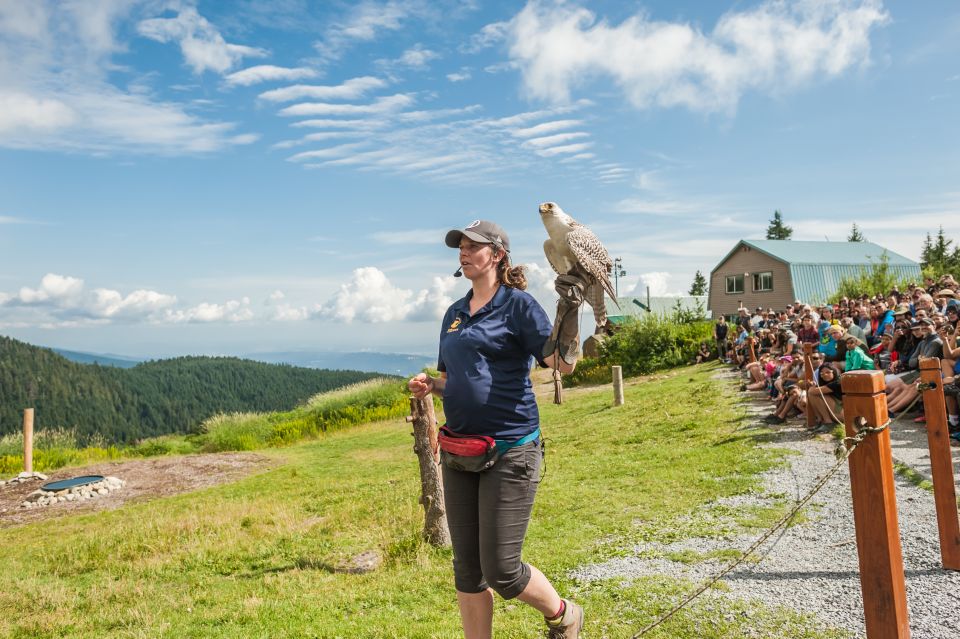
xmin=920 ymin=357 xmax=960 ymax=570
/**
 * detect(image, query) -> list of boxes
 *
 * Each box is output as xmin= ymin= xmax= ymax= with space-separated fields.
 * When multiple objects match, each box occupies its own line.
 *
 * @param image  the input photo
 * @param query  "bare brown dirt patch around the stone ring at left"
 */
xmin=0 ymin=453 xmax=277 ymax=528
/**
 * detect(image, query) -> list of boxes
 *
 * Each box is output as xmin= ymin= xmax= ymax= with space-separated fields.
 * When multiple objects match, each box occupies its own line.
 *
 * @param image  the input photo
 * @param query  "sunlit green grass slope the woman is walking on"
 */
xmin=0 ymin=369 xmax=844 ymax=639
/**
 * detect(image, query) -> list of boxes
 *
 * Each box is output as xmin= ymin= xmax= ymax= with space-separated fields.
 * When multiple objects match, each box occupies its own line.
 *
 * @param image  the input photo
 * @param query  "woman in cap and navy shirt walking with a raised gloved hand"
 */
xmin=408 ymin=220 xmax=583 ymax=639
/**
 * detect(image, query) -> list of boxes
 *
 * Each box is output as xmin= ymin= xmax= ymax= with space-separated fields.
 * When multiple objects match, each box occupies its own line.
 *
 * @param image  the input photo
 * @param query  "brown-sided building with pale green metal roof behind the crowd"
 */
xmin=707 ymin=240 xmax=921 ymax=316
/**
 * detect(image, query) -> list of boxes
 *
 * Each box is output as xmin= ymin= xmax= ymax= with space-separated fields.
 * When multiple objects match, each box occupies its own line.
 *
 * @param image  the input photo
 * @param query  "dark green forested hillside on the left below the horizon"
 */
xmin=0 ymin=336 xmax=382 ymax=443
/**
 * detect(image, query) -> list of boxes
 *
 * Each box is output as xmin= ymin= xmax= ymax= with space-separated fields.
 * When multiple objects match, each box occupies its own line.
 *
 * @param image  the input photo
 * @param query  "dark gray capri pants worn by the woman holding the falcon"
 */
xmin=443 ymin=439 xmax=543 ymax=599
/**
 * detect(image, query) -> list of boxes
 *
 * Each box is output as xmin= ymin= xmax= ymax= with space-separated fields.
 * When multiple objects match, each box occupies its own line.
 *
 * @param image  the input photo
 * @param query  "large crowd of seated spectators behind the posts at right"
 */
xmin=716 ymin=275 xmax=960 ymax=444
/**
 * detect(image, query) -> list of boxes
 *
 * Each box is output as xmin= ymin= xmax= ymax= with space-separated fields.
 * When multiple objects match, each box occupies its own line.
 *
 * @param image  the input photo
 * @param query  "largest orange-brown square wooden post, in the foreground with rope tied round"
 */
xmin=840 ymin=371 xmax=910 ymax=639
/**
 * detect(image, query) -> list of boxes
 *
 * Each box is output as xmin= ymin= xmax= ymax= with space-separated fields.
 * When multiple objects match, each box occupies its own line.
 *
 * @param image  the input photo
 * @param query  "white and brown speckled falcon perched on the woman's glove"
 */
xmin=540 ymin=202 xmax=620 ymax=333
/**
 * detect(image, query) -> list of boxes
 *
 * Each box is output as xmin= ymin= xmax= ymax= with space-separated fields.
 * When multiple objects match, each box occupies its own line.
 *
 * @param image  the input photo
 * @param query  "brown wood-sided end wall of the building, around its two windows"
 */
xmin=708 ymin=244 xmax=795 ymax=317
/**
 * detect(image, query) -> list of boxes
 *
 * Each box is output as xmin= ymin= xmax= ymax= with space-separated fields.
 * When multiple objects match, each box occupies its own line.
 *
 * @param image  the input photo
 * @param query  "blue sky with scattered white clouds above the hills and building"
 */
xmin=0 ymin=0 xmax=960 ymax=357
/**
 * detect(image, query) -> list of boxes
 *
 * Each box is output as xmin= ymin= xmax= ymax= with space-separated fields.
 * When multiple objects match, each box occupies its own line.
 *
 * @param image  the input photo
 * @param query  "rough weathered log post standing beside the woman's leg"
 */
xmin=407 ymin=395 xmax=450 ymax=546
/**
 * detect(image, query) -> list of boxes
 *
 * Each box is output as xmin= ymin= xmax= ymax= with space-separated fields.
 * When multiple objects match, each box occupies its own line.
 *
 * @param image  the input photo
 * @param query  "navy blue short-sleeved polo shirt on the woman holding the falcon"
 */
xmin=437 ymin=285 xmax=552 ymax=442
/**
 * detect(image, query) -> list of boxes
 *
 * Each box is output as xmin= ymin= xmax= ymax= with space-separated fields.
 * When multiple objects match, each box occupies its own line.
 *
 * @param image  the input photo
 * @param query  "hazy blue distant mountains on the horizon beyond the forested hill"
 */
xmin=52 ymin=348 xmax=428 ymax=376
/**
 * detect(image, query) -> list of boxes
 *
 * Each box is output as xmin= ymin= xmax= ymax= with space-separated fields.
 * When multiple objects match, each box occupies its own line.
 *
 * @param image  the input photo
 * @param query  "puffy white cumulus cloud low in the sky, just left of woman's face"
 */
xmin=316 ymin=266 xmax=456 ymax=324
